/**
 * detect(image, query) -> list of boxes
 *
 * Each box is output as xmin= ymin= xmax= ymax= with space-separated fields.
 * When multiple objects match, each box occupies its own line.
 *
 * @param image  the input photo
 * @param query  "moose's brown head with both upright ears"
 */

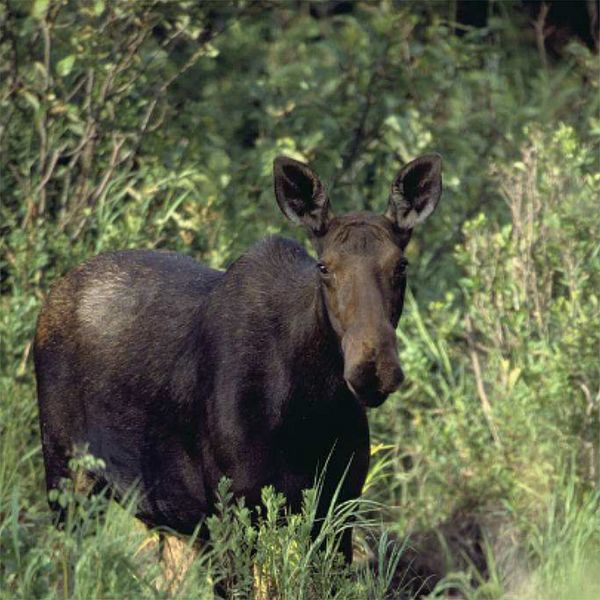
xmin=274 ymin=154 xmax=442 ymax=406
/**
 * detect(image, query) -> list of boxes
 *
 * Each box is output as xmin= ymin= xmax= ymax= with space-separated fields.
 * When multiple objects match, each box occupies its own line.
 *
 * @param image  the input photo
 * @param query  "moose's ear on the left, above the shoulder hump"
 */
xmin=273 ymin=156 xmax=333 ymax=237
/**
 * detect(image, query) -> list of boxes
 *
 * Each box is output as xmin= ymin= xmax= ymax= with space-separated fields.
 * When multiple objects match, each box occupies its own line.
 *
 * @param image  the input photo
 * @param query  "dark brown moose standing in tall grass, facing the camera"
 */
xmin=34 ymin=154 xmax=442 ymax=562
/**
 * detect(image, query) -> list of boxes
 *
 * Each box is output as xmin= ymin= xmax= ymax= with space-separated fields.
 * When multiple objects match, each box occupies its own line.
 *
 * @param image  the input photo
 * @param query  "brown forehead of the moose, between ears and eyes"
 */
xmin=321 ymin=213 xmax=402 ymax=266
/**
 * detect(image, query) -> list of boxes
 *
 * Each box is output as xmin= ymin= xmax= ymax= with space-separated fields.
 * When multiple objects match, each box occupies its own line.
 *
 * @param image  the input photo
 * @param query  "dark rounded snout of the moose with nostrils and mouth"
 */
xmin=343 ymin=334 xmax=404 ymax=406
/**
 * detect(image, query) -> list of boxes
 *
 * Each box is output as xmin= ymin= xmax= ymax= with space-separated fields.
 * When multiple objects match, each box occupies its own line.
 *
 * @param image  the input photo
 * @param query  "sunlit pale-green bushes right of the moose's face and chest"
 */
xmin=368 ymin=126 xmax=600 ymax=519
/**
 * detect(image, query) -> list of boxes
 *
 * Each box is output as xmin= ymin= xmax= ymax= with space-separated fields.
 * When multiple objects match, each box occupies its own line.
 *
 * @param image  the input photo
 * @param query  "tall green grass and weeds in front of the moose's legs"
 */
xmin=0 ymin=462 xmax=408 ymax=600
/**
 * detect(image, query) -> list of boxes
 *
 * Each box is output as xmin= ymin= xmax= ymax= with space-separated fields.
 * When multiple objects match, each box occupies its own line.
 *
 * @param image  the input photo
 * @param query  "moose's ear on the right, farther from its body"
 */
xmin=385 ymin=154 xmax=442 ymax=231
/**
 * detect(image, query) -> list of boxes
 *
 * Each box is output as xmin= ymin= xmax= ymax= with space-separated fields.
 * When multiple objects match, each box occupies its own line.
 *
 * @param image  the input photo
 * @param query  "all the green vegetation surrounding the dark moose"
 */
xmin=0 ymin=0 xmax=600 ymax=599
